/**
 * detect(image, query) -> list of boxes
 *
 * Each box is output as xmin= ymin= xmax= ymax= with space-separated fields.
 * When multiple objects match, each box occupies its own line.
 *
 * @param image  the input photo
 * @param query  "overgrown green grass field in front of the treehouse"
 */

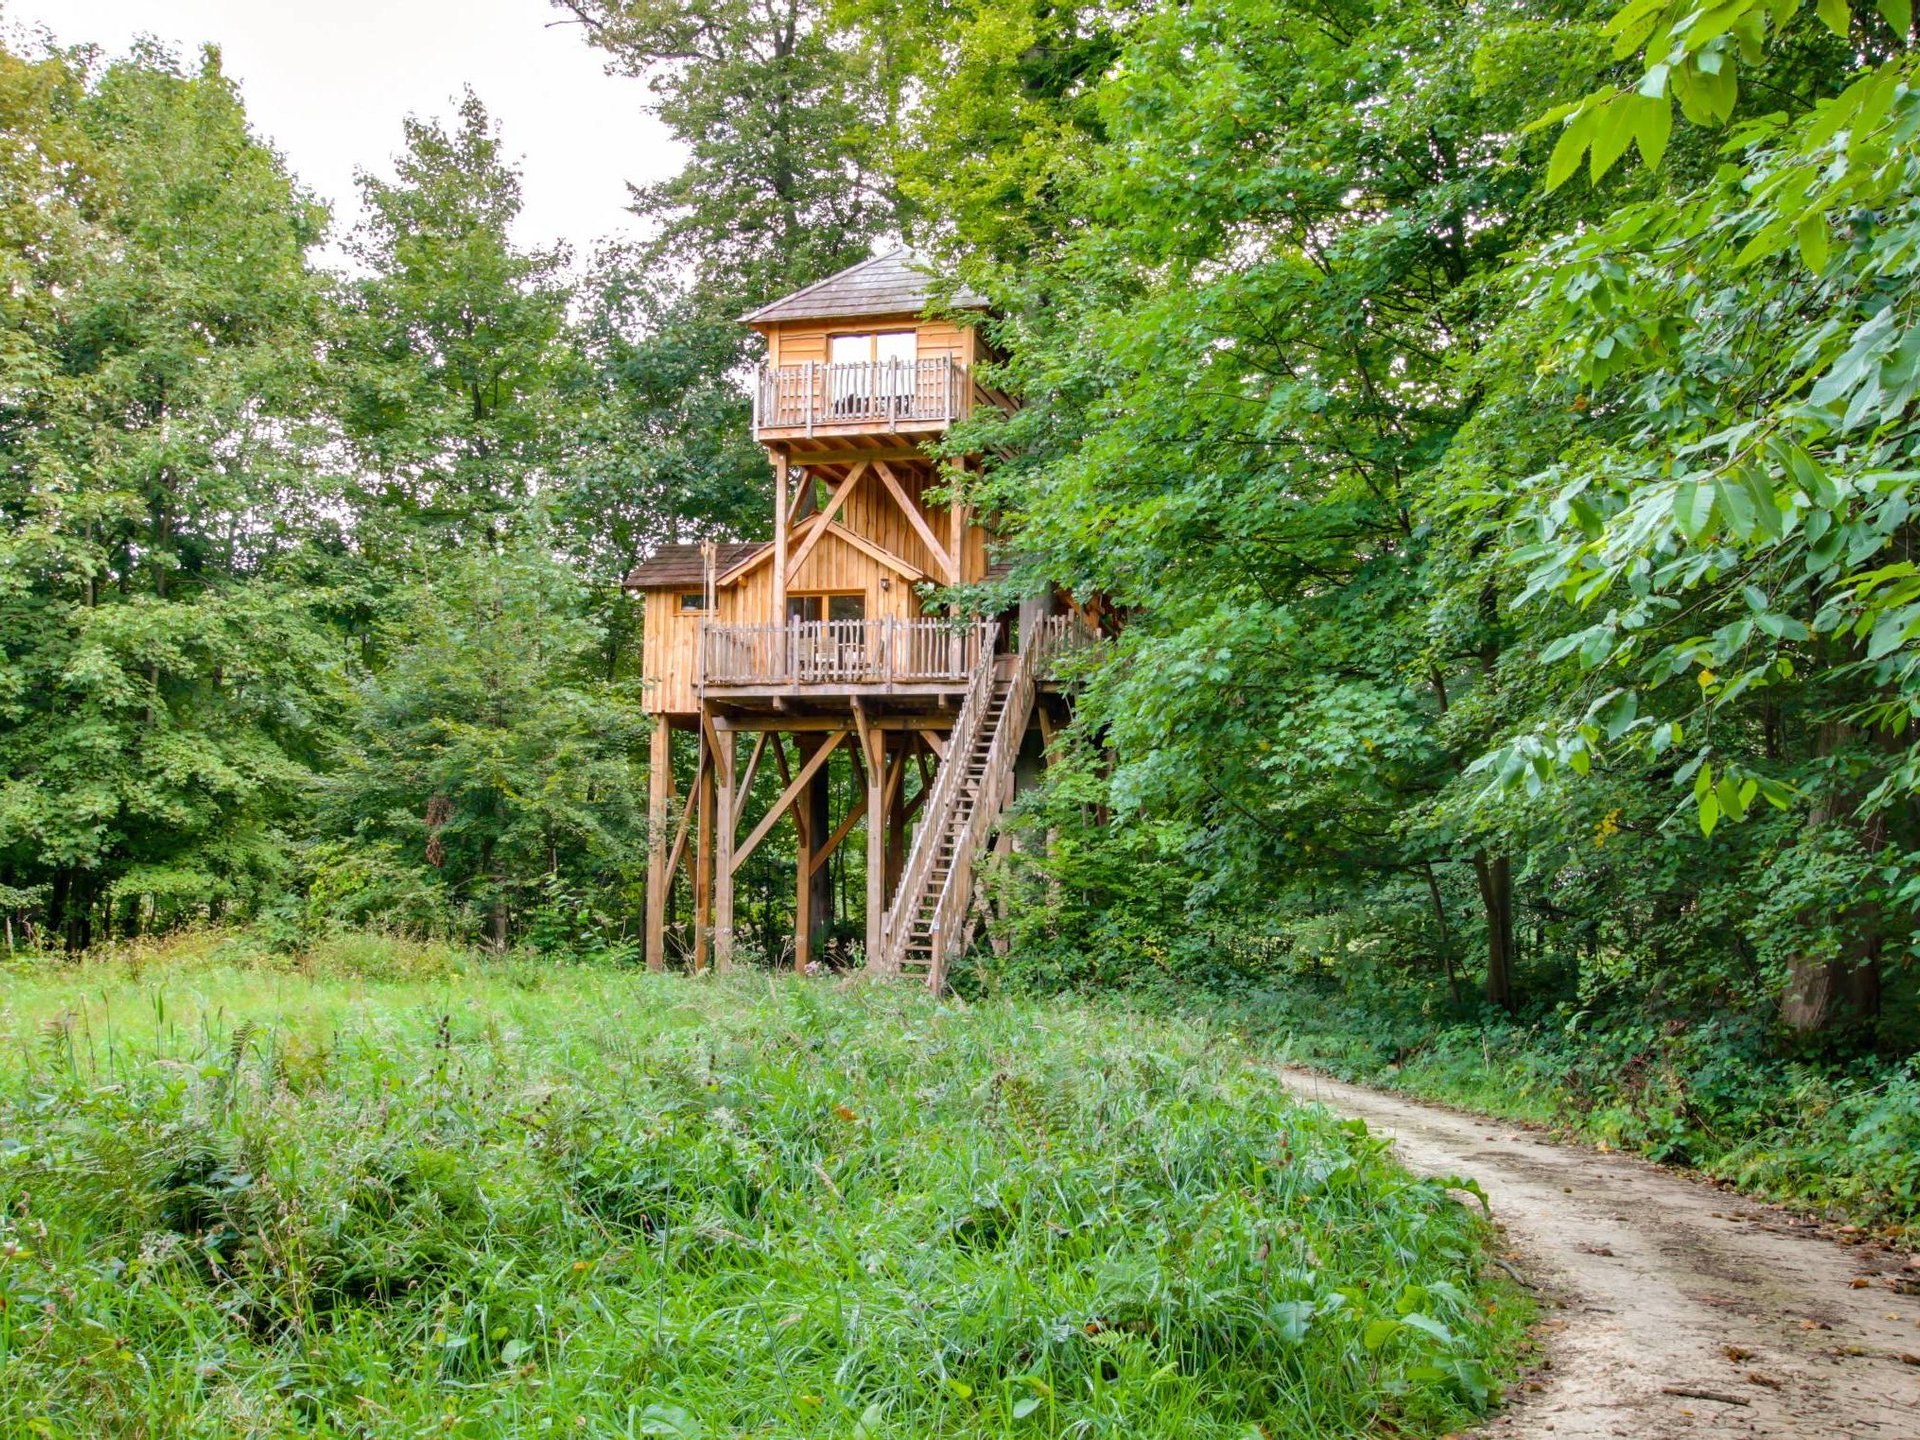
xmin=0 ymin=939 xmax=1526 ymax=1440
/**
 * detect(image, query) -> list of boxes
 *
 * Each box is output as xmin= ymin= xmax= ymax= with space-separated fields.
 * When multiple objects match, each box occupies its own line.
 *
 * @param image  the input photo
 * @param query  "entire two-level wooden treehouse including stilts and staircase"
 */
xmin=626 ymin=250 xmax=1085 ymax=989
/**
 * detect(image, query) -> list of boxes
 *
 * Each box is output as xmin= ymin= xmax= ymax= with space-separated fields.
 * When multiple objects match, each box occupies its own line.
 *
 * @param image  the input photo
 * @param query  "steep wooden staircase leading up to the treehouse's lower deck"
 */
xmin=876 ymin=616 xmax=1083 ymax=995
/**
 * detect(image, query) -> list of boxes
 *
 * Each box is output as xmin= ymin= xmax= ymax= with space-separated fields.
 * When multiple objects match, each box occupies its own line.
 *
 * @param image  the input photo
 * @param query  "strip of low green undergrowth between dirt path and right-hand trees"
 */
xmin=1213 ymin=981 xmax=1920 ymax=1235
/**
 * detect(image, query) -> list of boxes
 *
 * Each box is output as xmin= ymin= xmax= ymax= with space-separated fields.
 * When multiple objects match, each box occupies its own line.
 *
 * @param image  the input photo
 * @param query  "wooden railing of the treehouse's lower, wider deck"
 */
xmin=699 ymin=618 xmax=993 ymax=685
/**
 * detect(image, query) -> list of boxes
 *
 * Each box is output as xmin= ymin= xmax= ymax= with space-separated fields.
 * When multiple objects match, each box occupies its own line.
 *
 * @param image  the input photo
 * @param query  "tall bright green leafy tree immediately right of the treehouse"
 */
xmin=910 ymin=0 xmax=1599 ymax=1004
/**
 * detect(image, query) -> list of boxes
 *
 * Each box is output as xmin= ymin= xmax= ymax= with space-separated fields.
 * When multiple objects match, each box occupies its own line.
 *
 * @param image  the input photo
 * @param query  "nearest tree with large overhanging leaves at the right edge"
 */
xmin=1480 ymin=4 xmax=1920 ymax=1031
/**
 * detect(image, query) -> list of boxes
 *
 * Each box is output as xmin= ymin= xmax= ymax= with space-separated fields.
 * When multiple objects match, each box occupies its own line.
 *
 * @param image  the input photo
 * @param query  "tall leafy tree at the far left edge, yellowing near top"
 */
xmin=0 ymin=36 xmax=330 ymax=947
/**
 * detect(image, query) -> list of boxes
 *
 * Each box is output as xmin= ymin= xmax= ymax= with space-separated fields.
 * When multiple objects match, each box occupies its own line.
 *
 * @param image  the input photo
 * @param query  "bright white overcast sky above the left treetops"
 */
xmin=0 ymin=0 xmax=680 ymax=257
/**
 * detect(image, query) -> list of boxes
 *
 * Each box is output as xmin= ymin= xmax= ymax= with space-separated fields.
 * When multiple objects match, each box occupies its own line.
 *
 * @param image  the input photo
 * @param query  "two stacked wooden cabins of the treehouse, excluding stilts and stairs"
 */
xmin=626 ymin=250 xmax=1012 ymax=726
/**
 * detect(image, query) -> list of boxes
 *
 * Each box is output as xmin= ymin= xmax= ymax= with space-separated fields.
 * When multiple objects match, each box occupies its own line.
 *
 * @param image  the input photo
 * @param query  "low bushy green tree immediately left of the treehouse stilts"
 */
xmin=309 ymin=513 xmax=645 ymax=947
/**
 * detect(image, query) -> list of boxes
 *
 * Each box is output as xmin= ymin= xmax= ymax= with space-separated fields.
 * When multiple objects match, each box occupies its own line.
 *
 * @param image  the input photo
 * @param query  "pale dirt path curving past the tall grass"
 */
xmin=1286 ymin=1071 xmax=1920 ymax=1440
